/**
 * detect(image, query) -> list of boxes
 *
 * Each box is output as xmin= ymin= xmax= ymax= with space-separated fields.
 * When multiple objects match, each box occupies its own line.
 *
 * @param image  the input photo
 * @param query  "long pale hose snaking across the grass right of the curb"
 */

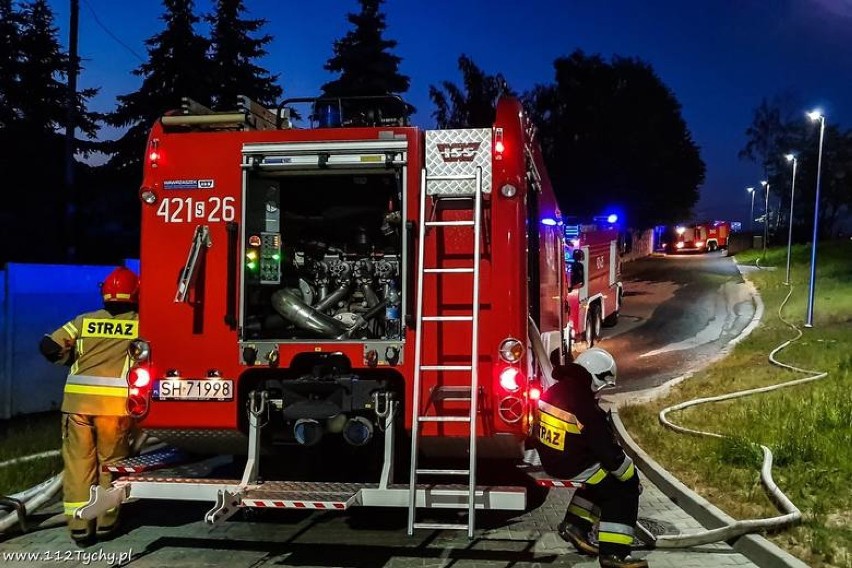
xmin=655 ymin=286 xmax=828 ymax=548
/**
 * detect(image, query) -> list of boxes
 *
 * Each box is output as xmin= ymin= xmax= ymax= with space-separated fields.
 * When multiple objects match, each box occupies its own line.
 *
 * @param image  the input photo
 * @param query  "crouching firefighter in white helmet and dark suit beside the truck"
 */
xmin=535 ymin=347 xmax=648 ymax=568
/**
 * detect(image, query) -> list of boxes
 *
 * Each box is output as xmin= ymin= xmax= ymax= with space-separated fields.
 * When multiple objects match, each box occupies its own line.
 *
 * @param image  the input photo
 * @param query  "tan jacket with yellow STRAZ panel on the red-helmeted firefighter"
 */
xmin=50 ymin=310 xmax=139 ymax=416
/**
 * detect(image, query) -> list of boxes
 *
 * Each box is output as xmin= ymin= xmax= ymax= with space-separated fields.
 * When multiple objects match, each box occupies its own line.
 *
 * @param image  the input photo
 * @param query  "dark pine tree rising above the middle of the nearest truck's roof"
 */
xmin=322 ymin=0 xmax=414 ymax=123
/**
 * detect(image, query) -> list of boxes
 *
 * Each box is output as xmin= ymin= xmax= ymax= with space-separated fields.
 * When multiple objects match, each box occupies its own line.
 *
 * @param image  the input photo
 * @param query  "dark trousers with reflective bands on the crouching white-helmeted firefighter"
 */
xmin=565 ymin=473 xmax=641 ymax=558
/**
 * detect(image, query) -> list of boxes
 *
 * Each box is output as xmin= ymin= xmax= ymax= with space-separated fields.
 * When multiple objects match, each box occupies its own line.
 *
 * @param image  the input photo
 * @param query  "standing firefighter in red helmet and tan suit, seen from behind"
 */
xmin=39 ymin=267 xmax=139 ymax=541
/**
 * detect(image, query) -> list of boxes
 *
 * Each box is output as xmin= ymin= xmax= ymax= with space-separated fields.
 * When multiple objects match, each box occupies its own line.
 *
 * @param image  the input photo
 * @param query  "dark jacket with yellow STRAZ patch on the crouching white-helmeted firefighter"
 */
xmin=534 ymin=363 xmax=634 ymax=484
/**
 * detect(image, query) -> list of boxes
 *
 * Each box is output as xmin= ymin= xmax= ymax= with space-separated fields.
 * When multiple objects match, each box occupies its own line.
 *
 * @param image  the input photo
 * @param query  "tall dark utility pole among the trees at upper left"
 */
xmin=65 ymin=0 xmax=80 ymax=262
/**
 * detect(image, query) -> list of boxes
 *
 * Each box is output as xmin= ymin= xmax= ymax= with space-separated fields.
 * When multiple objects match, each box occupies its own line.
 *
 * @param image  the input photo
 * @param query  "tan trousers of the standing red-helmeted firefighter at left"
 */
xmin=62 ymin=413 xmax=133 ymax=535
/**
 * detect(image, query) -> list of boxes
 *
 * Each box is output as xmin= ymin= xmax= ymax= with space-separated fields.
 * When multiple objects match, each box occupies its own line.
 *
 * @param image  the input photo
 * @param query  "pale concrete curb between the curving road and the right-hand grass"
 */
xmin=612 ymin=264 xmax=808 ymax=568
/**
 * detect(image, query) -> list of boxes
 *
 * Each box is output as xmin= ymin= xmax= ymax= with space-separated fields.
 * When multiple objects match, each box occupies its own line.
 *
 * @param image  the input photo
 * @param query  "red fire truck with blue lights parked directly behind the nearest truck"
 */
xmin=565 ymin=218 xmax=624 ymax=347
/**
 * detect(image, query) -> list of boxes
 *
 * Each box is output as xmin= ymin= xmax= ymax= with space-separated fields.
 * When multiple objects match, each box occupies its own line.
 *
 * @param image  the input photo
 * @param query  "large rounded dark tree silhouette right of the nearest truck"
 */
xmin=525 ymin=51 xmax=705 ymax=229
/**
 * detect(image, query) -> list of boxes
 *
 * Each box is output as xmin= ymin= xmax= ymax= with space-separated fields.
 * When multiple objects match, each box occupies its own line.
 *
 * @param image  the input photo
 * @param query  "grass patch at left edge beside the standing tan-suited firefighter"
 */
xmin=0 ymin=412 xmax=62 ymax=495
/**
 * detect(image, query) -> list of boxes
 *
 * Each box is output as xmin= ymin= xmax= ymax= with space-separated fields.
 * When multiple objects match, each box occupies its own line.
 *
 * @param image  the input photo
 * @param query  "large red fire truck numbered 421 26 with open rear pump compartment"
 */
xmin=77 ymin=94 xmax=572 ymax=535
